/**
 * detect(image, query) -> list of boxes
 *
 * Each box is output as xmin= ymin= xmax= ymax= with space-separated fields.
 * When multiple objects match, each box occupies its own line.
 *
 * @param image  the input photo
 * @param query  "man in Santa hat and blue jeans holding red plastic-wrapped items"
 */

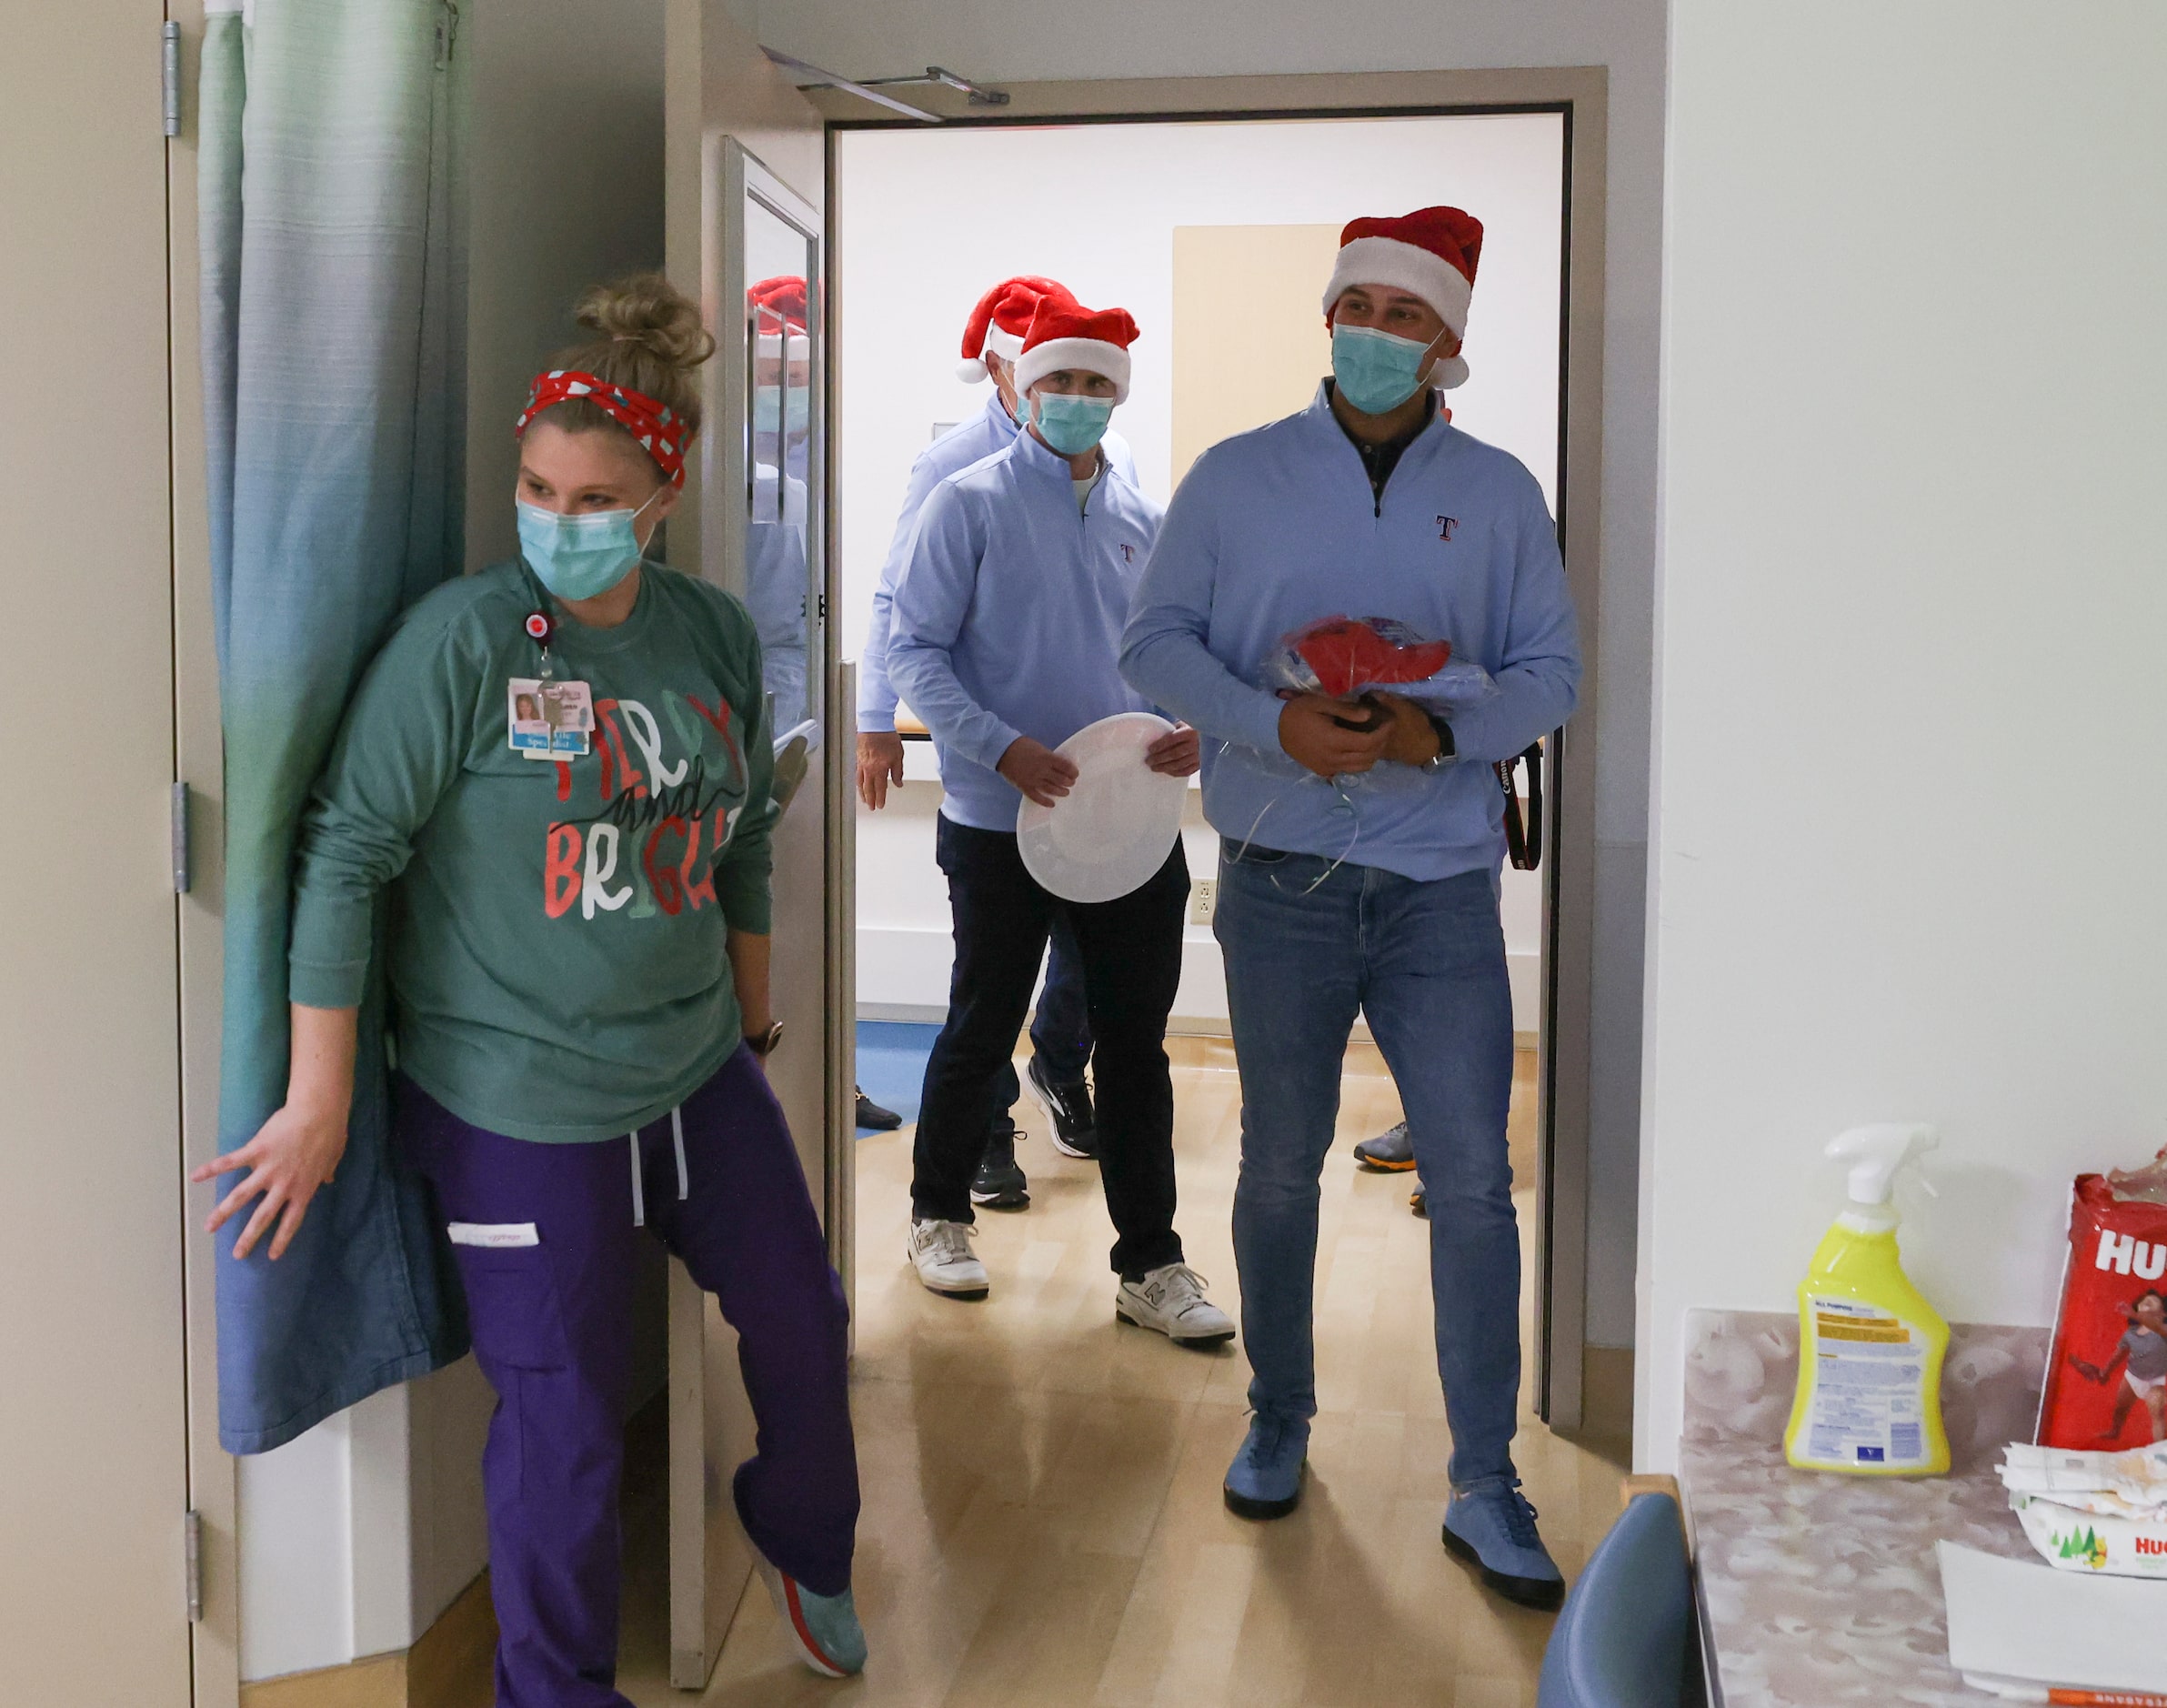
xmin=1122 ymin=208 xmax=1580 ymax=1606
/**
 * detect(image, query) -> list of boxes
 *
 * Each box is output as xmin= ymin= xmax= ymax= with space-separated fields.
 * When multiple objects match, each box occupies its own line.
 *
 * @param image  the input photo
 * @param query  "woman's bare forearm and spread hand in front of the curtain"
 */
xmin=188 ymin=1003 xmax=360 ymax=1261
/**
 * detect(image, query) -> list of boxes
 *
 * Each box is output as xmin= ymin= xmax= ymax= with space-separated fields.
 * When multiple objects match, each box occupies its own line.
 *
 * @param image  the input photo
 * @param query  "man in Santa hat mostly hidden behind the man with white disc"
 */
xmin=858 ymin=273 xmax=1136 ymax=1210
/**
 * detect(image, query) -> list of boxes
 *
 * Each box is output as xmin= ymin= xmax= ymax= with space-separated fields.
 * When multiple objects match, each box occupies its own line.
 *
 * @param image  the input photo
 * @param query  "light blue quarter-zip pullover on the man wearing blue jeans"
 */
xmin=1120 ymin=386 xmax=1580 ymax=880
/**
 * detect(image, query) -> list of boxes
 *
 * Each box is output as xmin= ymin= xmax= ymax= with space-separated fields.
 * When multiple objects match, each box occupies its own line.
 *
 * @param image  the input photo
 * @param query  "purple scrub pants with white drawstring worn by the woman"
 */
xmin=395 ymin=1049 xmax=858 ymax=1708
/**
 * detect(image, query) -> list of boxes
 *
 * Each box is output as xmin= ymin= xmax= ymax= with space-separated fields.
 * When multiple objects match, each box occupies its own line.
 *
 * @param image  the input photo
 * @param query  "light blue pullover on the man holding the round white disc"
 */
xmin=888 ymin=422 xmax=1161 ymax=830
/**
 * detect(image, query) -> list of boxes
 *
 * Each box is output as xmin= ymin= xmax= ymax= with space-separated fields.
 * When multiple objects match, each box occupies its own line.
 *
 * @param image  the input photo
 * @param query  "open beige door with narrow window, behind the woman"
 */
xmin=663 ymin=0 xmax=852 ymax=1689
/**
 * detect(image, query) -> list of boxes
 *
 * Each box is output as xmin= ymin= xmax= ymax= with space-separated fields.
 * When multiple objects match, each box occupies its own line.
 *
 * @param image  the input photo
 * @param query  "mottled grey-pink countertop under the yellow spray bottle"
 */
xmin=1680 ymin=1311 xmax=2046 ymax=1708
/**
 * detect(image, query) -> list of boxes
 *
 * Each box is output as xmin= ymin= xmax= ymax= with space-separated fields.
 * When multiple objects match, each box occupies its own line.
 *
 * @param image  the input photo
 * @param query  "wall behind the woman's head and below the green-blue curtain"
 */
xmin=238 ymin=0 xmax=663 ymax=1680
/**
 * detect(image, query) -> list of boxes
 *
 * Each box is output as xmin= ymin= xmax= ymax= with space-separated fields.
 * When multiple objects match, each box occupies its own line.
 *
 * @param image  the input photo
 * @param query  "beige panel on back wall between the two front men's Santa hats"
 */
xmin=1172 ymin=226 xmax=1339 ymax=486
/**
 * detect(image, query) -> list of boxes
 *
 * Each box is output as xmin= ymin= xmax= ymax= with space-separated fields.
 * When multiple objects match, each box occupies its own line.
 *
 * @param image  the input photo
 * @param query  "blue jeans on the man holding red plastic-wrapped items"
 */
xmin=1213 ymin=843 xmax=1519 ymax=1487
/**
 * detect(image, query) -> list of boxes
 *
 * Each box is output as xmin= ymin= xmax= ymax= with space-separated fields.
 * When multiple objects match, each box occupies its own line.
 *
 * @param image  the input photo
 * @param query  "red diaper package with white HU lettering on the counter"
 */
xmin=2037 ymin=1151 xmax=2167 ymax=1450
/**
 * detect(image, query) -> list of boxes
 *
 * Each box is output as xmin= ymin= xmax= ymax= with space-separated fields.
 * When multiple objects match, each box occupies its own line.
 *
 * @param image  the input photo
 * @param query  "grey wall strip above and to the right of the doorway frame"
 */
xmin=776 ymin=0 xmax=1655 ymax=1346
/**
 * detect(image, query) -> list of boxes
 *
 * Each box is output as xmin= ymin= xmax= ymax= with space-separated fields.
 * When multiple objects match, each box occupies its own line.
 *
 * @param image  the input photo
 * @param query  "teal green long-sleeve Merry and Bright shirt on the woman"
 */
xmin=288 ymin=564 xmax=774 ymax=1142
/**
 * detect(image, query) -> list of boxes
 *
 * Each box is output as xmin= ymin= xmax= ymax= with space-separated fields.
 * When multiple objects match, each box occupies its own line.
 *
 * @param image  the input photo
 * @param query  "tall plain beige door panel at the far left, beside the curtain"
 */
xmin=0 ymin=0 xmax=188 ymax=1708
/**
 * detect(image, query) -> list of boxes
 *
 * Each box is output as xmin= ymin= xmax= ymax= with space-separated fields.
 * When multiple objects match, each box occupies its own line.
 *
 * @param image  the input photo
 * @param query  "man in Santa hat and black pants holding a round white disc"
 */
xmin=888 ymin=297 xmax=1233 ymax=1346
